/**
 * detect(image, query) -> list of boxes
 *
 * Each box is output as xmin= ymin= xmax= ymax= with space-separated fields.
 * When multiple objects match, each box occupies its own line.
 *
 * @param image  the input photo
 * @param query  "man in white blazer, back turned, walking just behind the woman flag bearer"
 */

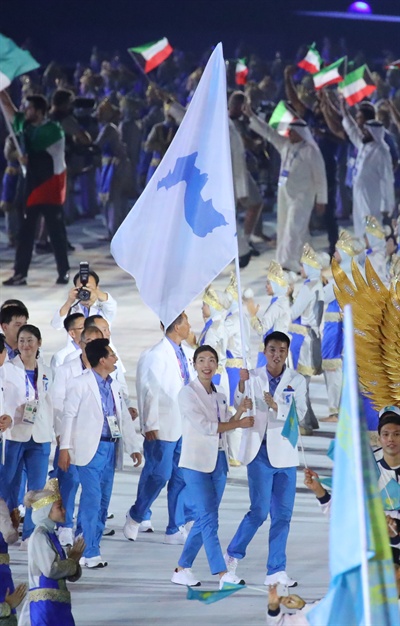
xmin=124 ymin=313 xmax=195 ymax=544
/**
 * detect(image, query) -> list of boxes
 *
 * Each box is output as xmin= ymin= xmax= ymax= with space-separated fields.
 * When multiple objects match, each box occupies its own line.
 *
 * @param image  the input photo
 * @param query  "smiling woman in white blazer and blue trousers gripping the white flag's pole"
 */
xmin=171 ymin=345 xmax=254 ymax=588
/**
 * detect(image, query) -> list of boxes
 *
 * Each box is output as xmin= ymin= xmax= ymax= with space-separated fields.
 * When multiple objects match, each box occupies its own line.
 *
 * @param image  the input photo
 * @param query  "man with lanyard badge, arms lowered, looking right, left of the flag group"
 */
xmin=58 ymin=339 xmax=141 ymax=568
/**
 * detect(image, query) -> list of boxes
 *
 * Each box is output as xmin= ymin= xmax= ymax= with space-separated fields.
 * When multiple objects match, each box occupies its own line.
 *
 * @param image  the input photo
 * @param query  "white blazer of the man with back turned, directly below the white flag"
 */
xmin=136 ymin=337 xmax=196 ymax=441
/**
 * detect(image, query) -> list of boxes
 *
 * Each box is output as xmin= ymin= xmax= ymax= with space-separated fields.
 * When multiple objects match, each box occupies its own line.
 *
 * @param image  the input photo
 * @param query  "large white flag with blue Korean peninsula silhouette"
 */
xmin=111 ymin=44 xmax=237 ymax=327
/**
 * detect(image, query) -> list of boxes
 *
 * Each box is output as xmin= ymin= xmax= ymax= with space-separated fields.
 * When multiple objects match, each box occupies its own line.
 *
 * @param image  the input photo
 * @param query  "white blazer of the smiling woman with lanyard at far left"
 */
xmin=3 ymin=356 xmax=54 ymax=443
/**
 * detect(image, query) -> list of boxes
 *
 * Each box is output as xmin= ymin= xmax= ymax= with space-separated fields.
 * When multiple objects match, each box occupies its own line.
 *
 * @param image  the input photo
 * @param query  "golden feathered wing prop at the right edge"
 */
xmin=332 ymin=258 xmax=394 ymax=411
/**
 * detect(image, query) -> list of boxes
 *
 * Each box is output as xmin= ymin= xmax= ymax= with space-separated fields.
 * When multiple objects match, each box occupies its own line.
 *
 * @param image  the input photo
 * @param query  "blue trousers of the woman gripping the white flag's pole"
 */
xmin=178 ymin=452 xmax=228 ymax=574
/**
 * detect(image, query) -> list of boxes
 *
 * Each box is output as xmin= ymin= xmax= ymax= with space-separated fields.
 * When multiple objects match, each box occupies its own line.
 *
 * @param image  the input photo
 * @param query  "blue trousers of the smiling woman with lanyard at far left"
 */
xmin=1 ymin=437 xmax=50 ymax=539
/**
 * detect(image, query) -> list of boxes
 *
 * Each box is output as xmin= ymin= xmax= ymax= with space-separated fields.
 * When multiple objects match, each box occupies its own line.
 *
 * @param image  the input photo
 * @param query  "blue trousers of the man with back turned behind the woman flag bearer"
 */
xmin=129 ymin=439 xmax=194 ymax=535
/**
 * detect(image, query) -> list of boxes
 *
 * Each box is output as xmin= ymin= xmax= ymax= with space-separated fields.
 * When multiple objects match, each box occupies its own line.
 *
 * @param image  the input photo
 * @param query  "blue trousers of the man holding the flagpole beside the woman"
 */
xmin=227 ymin=443 xmax=296 ymax=574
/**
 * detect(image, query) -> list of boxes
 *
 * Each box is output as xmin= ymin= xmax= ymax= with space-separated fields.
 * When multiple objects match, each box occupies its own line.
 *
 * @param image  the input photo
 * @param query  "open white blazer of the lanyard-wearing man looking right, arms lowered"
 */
xmin=60 ymin=370 xmax=140 ymax=469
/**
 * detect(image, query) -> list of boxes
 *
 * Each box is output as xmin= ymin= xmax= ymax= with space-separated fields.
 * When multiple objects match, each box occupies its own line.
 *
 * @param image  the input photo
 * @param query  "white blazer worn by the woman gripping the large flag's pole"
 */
xmin=178 ymin=378 xmax=230 ymax=473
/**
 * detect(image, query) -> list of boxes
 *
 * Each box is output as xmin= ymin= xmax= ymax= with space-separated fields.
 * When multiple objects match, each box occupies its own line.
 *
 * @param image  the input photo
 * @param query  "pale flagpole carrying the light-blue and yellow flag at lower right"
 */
xmin=344 ymin=304 xmax=372 ymax=626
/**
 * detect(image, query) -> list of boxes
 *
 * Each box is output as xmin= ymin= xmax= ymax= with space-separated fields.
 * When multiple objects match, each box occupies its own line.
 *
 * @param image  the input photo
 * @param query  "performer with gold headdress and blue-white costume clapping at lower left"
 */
xmin=25 ymin=478 xmax=85 ymax=626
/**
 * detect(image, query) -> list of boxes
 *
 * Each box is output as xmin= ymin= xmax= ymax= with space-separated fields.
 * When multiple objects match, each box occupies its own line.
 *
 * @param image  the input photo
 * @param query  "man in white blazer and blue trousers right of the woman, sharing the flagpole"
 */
xmin=225 ymin=331 xmax=307 ymax=587
